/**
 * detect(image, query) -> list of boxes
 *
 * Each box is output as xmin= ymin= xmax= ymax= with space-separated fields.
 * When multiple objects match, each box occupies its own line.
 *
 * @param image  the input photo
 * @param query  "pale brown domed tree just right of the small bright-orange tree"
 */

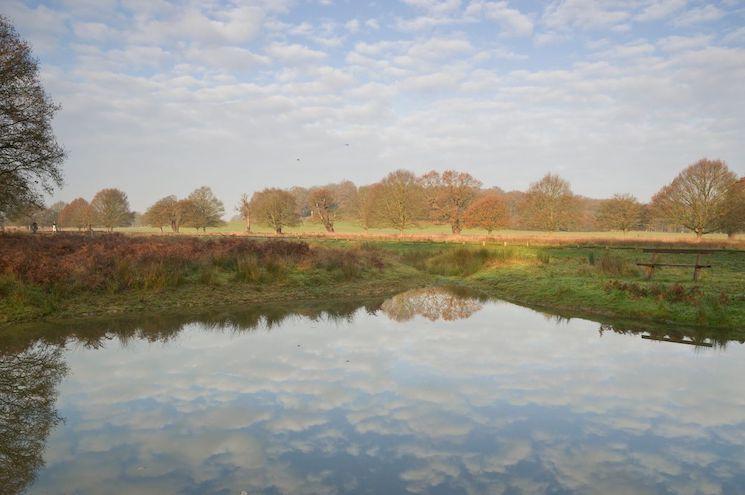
xmin=523 ymin=174 xmax=578 ymax=231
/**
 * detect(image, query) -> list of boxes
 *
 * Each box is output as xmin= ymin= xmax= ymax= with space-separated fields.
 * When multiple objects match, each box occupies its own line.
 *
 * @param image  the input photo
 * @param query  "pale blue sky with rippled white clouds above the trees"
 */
xmin=5 ymin=0 xmax=745 ymax=213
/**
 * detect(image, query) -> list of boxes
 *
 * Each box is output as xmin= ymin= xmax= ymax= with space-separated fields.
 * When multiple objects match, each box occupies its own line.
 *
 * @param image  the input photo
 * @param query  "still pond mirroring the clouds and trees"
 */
xmin=0 ymin=289 xmax=745 ymax=494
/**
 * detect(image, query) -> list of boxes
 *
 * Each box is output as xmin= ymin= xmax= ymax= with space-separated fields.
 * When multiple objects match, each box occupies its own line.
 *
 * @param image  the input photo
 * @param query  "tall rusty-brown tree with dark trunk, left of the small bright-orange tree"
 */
xmin=421 ymin=170 xmax=481 ymax=234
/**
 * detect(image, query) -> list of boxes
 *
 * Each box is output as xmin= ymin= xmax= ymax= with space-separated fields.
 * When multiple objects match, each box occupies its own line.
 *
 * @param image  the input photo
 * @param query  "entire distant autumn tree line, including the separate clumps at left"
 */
xmin=2 ymin=159 xmax=745 ymax=238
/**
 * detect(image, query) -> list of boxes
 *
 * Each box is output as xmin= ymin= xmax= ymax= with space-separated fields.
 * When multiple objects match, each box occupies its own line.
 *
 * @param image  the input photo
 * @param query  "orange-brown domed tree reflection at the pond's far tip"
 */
xmin=381 ymin=287 xmax=483 ymax=321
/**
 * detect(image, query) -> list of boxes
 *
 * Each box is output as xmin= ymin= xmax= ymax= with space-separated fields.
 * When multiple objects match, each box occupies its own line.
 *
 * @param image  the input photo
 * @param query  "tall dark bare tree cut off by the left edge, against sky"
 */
xmin=0 ymin=16 xmax=65 ymax=217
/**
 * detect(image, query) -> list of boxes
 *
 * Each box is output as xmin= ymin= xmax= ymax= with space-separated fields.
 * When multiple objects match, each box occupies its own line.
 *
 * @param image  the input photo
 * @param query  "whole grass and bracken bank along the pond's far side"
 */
xmin=0 ymin=235 xmax=745 ymax=330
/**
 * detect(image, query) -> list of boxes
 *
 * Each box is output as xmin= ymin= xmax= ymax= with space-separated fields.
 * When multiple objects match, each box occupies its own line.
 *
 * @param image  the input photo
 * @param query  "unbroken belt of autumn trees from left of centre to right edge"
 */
xmin=230 ymin=159 xmax=745 ymax=238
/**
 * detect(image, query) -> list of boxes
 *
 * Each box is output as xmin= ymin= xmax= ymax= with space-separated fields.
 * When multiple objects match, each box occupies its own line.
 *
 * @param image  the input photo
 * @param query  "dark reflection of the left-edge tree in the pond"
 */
xmin=0 ymin=345 xmax=67 ymax=494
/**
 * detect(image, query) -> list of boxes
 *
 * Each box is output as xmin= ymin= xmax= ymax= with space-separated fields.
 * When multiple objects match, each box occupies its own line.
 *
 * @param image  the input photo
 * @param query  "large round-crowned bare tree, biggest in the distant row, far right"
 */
xmin=652 ymin=158 xmax=737 ymax=240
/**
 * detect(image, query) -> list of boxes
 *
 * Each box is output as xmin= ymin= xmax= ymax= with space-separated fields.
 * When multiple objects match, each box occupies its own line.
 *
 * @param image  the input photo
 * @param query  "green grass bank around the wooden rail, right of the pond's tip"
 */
xmin=338 ymin=242 xmax=745 ymax=331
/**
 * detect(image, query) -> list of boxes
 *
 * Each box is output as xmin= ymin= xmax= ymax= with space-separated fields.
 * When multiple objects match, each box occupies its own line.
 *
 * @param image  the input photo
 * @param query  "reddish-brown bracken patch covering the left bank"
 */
xmin=0 ymin=234 xmax=311 ymax=291
